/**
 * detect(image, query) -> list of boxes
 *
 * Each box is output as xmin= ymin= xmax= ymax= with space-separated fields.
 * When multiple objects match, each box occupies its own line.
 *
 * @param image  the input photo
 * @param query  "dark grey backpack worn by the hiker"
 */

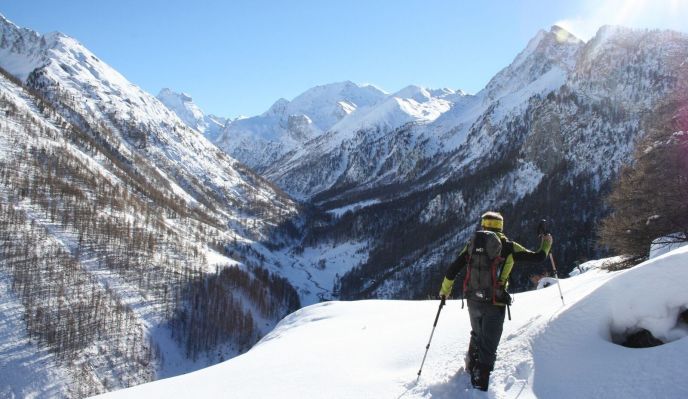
xmin=463 ymin=230 xmax=504 ymax=303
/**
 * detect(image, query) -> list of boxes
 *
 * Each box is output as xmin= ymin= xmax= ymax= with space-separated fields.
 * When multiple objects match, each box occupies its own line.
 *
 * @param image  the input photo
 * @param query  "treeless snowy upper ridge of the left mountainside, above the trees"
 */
xmin=0 ymin=13 xmax=296 ymax=241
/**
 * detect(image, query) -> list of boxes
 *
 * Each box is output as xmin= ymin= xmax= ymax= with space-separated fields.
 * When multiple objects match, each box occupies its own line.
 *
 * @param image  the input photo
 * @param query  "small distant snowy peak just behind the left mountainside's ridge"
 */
xmin=157 ymin=89 xmax=228 ymax=142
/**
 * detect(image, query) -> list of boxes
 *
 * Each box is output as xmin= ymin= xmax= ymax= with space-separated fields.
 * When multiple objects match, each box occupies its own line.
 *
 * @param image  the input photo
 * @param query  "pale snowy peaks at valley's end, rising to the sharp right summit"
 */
xmin=183 ymin=27 xmax=583 ymax=198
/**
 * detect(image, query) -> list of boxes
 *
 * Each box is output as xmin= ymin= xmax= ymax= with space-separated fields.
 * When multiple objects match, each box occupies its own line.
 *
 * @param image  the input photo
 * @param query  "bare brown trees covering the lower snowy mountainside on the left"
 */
xmin=0 ymin=63 xmax=300 ymax=397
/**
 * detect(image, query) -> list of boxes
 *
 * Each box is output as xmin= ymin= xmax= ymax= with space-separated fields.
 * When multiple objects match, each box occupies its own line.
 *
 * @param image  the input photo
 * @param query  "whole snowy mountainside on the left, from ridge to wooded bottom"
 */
xmin=0 ymin=16 xmax=299 ymax=397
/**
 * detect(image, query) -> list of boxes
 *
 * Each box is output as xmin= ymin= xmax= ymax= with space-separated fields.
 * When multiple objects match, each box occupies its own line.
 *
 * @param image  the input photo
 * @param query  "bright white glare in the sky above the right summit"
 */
xmin=556 ymin=0 xmax=688 ymax=40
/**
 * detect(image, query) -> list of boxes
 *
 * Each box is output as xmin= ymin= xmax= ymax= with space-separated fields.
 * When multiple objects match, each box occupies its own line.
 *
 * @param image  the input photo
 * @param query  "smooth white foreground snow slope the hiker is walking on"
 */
xmin=95 ymin=248 xmax=688 ymax=399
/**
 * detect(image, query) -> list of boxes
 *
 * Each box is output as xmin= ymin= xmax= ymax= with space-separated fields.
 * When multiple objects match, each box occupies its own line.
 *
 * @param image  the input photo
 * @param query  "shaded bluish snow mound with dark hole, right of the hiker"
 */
xmin=532 ymin=248 xmax=688 ymax=398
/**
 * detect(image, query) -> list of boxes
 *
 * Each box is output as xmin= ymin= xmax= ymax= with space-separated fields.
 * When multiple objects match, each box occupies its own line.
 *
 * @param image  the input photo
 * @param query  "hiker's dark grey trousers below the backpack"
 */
xmin=468 ymin=300 xmax=505 ymax=370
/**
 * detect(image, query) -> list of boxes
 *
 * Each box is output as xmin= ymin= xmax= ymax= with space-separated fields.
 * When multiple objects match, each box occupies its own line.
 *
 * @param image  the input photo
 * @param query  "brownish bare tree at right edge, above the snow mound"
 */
xmin=599 ymin=91 xmax=688 ymax=259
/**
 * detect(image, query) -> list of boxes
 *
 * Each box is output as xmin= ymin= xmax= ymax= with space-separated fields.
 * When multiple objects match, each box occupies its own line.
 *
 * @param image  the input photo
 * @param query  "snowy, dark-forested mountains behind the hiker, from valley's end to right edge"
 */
xmin=161 ymin=26 xmax=688 ymax=304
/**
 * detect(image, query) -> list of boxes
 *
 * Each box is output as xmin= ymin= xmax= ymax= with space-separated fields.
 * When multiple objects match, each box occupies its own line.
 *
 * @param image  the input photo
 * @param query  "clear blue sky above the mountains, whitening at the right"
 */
xmin=0 ymin=0 xmax=688 ymax=117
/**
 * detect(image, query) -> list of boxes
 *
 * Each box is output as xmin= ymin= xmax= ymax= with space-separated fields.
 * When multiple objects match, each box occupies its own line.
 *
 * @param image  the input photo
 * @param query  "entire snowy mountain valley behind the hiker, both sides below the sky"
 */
xmin=0 ymin=11 xmax=688 ymax=397
